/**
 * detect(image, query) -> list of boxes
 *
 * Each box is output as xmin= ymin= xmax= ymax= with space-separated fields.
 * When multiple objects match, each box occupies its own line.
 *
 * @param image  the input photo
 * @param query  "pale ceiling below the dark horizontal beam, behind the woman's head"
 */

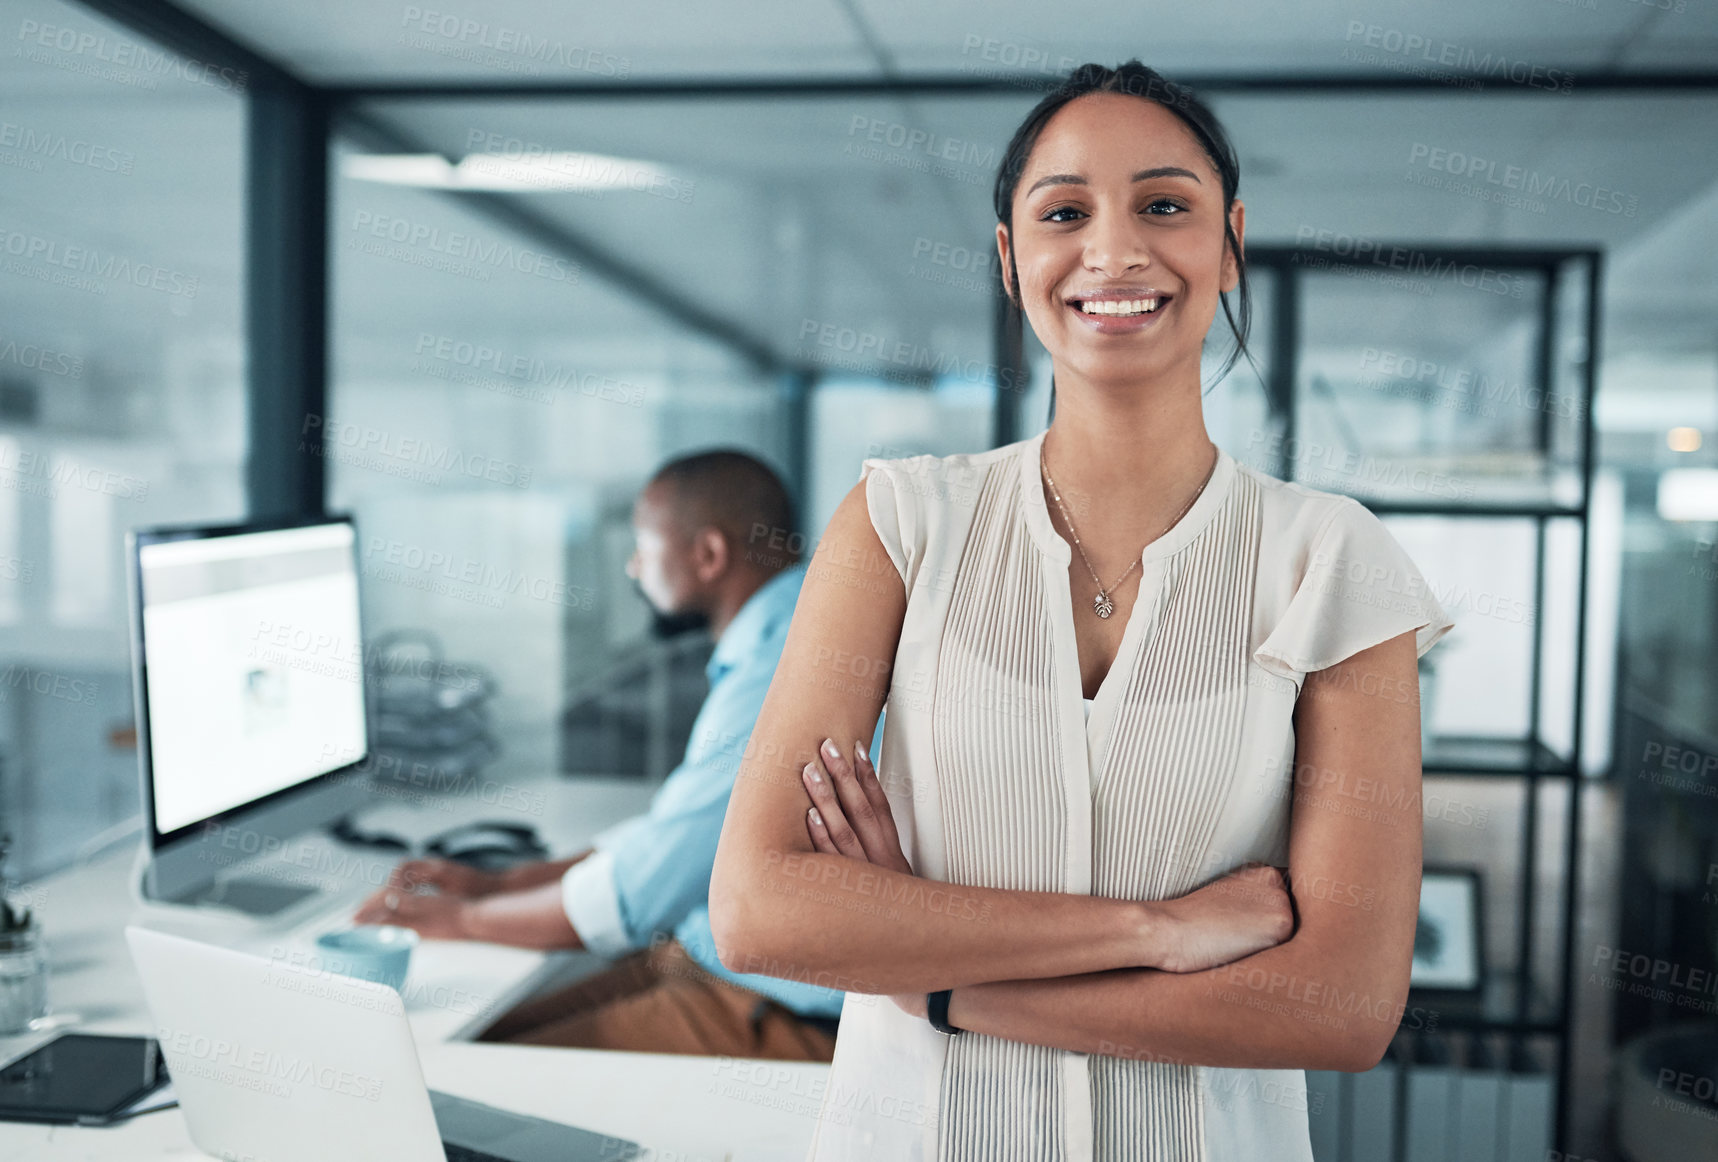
xmin=335 ymin=87 xmax=1718 ymax=376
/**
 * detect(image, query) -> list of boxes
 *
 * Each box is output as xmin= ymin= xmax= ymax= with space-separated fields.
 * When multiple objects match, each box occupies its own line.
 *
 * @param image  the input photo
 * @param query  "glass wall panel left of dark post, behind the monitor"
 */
xmin=0 ymin=0 xmax=246 ymax=878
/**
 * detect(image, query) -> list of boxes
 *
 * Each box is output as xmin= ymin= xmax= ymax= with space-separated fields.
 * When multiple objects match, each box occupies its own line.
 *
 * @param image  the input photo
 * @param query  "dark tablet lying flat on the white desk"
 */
xmin=0 ymin=1033 xmax=167 ymax=1124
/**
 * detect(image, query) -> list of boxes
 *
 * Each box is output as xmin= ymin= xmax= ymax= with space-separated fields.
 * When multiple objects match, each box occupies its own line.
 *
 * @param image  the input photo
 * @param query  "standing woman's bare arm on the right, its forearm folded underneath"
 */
xmin=927 ymin=634 xmax=1435 ymax=1071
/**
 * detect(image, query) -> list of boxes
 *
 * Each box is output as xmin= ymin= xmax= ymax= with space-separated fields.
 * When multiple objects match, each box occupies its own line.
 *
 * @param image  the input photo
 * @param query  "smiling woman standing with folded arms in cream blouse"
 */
xmin=711 ymin=62 xmax=1453 ymax=1162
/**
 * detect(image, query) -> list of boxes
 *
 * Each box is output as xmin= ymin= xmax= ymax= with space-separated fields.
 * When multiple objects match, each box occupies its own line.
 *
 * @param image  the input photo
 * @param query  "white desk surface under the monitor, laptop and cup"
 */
xmin=0 ymin=777 xmax=828 ymax=1162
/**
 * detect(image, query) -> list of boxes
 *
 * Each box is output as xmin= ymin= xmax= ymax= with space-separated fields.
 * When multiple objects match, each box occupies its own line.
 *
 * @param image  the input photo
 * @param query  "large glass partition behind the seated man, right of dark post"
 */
xmin=326 ymin=98 xmax=1019 ymax=777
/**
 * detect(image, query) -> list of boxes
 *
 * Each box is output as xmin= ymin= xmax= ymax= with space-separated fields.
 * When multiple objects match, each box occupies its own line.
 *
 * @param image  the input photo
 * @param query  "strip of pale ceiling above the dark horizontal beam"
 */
xmin=170 ymin=0 xmax=1718 ymax=84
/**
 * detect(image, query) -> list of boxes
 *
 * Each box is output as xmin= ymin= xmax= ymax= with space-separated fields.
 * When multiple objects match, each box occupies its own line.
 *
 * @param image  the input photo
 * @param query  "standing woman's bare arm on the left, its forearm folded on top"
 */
xmin=710 ymin=481 xmax=1161 ymax=994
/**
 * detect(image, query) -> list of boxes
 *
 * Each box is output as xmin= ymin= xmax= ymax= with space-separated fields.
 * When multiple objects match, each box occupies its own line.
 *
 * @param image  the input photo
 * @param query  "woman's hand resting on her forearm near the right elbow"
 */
xmin=1153 ymin=863 xmax=1295 ymax=973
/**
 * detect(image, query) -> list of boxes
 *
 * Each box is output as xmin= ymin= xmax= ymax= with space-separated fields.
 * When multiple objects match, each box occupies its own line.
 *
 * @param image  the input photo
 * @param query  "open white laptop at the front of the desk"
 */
xmin=125 ymin=927 xmax=639 ymax=1162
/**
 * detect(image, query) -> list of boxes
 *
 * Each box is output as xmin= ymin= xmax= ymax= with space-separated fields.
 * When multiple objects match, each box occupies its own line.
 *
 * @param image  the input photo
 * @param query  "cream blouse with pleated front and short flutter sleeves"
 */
xmin=809 ymin=433 xmax=1453 ymax=1162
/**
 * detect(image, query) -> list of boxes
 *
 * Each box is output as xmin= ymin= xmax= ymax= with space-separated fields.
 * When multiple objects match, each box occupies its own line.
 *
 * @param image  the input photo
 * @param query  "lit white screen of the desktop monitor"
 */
xmin=137 ymin=521 xmax=368 ymax=835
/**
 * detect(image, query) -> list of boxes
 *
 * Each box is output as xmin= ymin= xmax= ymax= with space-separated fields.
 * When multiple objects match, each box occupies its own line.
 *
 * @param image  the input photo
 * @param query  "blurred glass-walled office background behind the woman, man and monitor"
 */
xmin=0 ymin=0 xmax=1718 ymax=1162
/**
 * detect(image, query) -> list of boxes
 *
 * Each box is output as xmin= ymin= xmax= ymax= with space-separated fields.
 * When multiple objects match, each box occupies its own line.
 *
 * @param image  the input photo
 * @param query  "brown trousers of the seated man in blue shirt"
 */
xmin=478 ymin=940 xmax=835 ymax=1061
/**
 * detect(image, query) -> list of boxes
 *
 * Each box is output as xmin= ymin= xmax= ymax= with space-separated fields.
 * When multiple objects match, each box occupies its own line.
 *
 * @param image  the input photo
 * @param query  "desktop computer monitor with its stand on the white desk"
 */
xmin=127 ymin=517 xmax=369 ymax=914
